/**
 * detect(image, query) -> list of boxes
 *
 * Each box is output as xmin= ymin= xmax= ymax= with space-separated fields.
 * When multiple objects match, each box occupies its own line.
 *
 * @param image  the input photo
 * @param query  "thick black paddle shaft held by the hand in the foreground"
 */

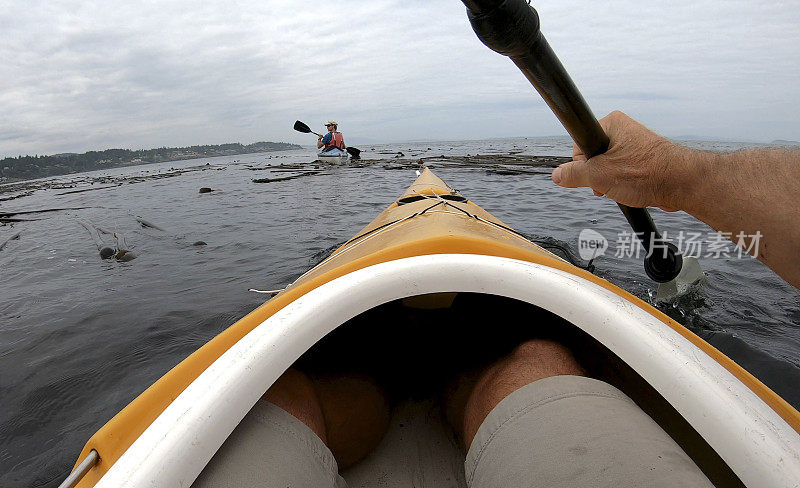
xmin=462 ymin=0 xmax=683 ymax=283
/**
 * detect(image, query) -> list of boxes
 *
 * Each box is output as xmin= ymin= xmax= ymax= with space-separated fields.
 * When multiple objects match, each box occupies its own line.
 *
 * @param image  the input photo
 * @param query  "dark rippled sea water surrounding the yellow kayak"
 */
xmin=0 ymin=138 xmax=800 ymax=487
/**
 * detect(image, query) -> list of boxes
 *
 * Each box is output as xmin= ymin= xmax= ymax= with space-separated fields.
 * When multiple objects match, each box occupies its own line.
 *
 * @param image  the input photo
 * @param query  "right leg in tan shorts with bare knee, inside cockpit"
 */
xmin=448 ymin=341 xmax=711 ymax=488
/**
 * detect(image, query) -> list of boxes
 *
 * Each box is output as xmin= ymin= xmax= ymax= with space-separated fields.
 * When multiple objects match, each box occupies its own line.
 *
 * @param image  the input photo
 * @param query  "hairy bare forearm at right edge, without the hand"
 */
xmin=676 ymin=147 xmax=800 ymax=288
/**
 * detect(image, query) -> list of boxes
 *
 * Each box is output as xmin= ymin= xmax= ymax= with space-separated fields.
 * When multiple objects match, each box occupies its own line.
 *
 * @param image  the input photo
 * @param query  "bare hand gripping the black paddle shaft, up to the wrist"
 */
xmin=552 ymin=111 xmax=692 ymax=211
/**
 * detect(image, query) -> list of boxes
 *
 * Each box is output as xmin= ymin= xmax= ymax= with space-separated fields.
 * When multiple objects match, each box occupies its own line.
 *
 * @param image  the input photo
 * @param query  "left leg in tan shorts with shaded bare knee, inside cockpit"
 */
xmin=193 ymin=369 xmax=389 ymax=488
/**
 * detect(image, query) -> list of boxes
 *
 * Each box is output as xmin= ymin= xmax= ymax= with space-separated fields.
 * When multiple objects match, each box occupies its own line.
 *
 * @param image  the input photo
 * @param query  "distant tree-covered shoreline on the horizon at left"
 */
xmin=0 ymin=142 xmax=303 ymax=184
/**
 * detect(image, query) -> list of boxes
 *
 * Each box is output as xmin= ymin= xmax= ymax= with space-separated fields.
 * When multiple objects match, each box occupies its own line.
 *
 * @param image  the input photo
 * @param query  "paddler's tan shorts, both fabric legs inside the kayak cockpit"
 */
xmin=193 ymin=376 xmax=712 ymax=488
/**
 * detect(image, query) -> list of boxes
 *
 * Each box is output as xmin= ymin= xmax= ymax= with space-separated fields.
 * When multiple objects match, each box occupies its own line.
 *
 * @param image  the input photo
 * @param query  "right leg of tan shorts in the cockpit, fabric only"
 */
xmin=465 ymin=376 xmax=713 ymax=488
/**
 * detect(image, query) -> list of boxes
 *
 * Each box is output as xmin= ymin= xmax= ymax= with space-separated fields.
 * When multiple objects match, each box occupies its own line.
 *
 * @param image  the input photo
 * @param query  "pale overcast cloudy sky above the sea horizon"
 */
xmin=0 ymin=0 xmax=800 ymax=157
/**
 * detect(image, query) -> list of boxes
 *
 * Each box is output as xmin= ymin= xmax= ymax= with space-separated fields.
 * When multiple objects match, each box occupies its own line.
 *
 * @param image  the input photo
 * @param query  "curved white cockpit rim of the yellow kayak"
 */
xmin=96 ymin=254 xmax=800 ymax=487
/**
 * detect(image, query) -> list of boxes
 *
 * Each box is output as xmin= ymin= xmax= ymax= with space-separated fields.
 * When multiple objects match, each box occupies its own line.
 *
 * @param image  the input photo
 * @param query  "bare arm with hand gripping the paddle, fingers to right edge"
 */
xmin=553 ymin=112 xmax=800 ymax=288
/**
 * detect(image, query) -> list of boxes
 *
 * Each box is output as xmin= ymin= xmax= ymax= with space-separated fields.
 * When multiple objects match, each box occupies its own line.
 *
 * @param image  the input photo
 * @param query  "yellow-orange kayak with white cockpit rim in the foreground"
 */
xmin=62 ymin=168 xmax=800 ymax=487
